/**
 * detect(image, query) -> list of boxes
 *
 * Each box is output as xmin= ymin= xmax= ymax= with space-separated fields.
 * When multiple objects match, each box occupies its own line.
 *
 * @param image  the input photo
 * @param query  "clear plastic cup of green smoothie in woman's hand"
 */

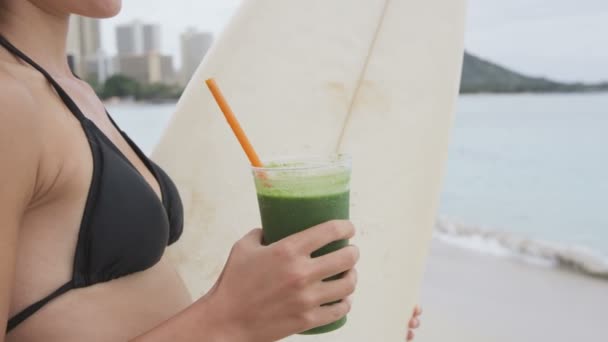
xmin=254 ymin=156 xmax=350 ymax=334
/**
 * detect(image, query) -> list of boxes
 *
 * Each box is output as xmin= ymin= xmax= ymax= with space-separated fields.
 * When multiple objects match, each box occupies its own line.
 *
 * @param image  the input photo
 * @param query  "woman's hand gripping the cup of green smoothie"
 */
xmin=195 ymin=221 xmax=359 ymax=342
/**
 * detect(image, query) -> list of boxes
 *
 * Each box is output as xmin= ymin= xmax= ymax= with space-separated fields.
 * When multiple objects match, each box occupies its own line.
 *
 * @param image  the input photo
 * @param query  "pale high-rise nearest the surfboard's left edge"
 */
xmin=180 ymin=28 xmax=213 ymax=85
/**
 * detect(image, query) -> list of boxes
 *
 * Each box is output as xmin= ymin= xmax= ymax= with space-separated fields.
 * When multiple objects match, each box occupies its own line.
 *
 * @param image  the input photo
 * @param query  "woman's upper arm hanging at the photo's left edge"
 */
xmin=0 ymin=83 xmax=40 ymax=342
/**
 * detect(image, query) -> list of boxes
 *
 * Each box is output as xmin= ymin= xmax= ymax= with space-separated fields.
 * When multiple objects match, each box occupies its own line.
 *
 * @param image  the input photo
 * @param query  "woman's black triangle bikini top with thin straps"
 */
xmin=0 ymin=35 xmax=183 ymax=332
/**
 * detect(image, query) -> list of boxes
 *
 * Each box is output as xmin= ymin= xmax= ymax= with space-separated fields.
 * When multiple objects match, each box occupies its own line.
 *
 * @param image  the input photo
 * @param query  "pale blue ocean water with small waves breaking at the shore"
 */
xmin=108 ymin=93 xmax=608 ymax=278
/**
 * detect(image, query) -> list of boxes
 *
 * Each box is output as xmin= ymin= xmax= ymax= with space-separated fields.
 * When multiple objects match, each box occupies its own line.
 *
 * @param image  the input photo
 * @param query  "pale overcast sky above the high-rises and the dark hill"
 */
xmin=102 ymin=0 xmax=608 ymax=82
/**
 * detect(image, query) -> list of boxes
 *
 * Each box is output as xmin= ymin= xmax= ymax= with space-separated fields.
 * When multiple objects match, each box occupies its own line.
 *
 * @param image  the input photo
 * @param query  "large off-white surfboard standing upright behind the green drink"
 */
xmin=153 ymin=0 xmax=465 ymax=342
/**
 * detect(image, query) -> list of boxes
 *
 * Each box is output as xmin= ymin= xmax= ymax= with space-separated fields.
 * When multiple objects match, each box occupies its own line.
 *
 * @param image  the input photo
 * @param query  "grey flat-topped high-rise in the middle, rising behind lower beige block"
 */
xmin=116 ymin=21 xmax=160 ymax=56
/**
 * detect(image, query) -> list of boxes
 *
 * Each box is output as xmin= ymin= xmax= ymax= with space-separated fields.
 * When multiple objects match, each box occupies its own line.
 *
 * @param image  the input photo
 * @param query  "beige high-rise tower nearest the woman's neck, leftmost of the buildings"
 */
xmin=67 ymin=15 xmax=110 ymax=83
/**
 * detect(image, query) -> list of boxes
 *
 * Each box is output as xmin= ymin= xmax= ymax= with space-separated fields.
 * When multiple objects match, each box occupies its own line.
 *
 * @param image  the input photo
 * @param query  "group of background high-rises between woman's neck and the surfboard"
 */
xmin=67 ymin=15 xmax=213 ymax=86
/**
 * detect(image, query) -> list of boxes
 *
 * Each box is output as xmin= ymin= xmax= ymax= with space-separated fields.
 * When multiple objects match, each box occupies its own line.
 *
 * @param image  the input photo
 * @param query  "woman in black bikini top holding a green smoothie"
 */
xmin=0 ymin=0 xmax=420 ymax=342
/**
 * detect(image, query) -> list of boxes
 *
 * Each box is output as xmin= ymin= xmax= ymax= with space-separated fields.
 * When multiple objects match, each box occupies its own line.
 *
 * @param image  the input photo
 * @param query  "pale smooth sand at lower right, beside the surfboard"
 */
xmin=416 ymin=239 xmax=608 ymax=342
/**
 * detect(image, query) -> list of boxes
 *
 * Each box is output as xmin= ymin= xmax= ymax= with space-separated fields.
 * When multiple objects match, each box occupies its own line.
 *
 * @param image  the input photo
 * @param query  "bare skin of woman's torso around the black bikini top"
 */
xmin=0 ymin=49 xmax=191 ymax=342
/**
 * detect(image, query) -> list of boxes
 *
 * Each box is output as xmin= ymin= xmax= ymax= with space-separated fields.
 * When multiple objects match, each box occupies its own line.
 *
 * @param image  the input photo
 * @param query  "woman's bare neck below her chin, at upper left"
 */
xmin=0 ymin=0 xmax=71 ymax=76
